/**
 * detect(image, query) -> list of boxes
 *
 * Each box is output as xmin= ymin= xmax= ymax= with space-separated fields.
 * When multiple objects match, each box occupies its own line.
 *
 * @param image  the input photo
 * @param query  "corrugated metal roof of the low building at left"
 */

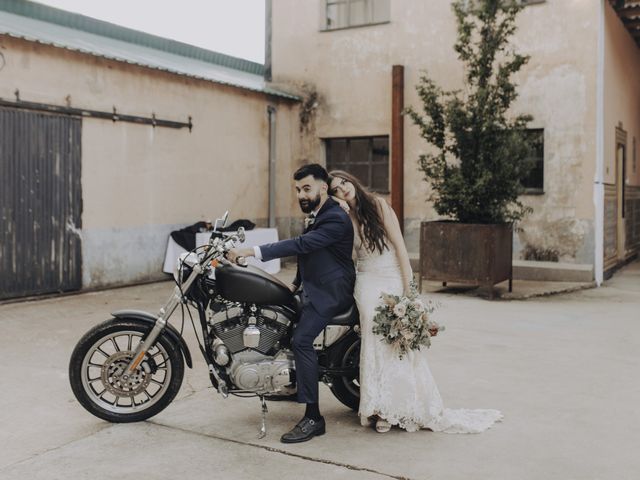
xmin=0 ymin=0 xmax=300 ymax=100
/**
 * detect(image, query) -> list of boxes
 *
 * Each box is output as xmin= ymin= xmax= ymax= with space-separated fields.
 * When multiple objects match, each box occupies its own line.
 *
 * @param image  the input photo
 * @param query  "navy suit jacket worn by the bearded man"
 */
xmin=260 ymin=198 xmax=355 ymax=317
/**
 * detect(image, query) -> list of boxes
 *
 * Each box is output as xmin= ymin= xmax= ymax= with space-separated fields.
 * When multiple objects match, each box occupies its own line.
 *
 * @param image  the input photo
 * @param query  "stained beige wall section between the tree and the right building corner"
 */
xmin=514 ymin=0 xmax=599 ymax=264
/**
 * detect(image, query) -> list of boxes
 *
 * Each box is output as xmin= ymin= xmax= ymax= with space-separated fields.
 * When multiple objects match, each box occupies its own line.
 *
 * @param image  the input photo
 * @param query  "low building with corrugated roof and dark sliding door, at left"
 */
xmin=0 ymin=0 xmax=297 ymax=298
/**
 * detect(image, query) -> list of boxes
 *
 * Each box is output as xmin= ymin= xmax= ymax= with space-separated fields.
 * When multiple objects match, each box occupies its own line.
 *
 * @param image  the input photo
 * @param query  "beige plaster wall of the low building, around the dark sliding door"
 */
xmin=0 ymin=37 xmax=297 ymax=287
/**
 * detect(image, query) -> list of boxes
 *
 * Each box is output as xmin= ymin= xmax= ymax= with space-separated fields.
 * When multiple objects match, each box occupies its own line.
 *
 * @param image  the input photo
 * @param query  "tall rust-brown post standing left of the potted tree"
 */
xmin=391 ymin=65 xmax=404 ymax=231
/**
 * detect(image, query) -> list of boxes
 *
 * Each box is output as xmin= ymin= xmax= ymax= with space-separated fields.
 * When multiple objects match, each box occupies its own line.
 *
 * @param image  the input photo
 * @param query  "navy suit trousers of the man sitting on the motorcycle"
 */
xmin=291 ymin=303 xmax=331 ymax=403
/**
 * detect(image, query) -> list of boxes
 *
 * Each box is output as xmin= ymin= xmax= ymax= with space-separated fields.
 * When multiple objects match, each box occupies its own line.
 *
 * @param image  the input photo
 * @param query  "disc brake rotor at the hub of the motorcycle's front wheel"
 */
xmin=101 ymin=351 xmax=153 ymax=397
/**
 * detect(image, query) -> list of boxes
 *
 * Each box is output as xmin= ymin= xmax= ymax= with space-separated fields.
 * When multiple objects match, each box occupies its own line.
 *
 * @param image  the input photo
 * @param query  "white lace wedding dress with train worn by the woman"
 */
xmin=354 ymin=234 xmax=502 ymax=433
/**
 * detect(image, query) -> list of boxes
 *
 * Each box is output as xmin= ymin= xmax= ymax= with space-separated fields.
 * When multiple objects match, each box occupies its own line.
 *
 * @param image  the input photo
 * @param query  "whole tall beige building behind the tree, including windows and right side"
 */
xmin=267 ymin=0 xmax=640 ymax=282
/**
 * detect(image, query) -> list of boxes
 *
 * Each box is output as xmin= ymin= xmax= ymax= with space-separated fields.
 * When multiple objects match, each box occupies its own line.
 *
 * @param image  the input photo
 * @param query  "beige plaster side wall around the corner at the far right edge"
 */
xmin=604 ymin=2 xmax=640 ymax=186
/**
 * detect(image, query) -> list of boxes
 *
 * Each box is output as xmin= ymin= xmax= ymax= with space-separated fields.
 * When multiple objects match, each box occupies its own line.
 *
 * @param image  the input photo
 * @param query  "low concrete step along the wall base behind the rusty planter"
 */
xmin=409 ymin=253 xmax=593 ymax=282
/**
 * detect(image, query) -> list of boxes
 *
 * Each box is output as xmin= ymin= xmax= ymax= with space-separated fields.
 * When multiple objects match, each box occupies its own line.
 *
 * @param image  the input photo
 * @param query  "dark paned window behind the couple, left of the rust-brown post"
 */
xmin=324 ymin=136 xmax=389 ymax=193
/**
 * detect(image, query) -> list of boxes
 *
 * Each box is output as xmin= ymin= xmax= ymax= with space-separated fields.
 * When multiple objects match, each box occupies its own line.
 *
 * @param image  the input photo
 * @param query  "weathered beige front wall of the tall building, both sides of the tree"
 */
xmin=272 ymin=0 xmax=598 ymax=263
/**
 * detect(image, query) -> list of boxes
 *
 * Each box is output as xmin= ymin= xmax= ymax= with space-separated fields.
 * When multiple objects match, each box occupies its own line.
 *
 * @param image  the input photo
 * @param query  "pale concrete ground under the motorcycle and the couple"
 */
xmin=0 ymin=262 xmax=640 ymax=480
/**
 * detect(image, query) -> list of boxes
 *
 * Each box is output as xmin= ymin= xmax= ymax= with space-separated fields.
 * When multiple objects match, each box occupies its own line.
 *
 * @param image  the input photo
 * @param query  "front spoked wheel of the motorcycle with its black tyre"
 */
xmin=69 ymin=319 xmax=184 ymax=422
